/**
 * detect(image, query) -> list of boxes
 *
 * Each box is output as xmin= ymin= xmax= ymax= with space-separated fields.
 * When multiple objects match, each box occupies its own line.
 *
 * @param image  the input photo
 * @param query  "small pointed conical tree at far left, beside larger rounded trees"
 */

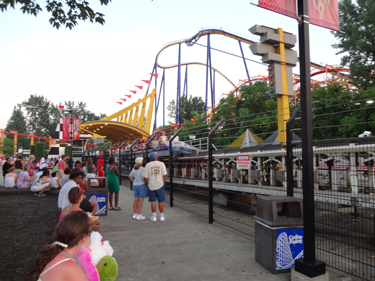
xmin=5 ymin=104 xmax=30 ymax=149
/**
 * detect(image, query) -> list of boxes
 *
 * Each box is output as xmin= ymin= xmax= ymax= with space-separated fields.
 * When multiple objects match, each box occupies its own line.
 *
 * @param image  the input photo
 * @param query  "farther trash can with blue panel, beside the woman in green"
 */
xmin=86 ymin=177 xmax=108 ymax=216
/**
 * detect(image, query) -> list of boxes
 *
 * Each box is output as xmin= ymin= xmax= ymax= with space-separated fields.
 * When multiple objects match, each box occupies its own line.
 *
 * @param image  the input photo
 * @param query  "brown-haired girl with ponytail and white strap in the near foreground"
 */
xmin=26 ymin=211 xmax=90 ymax=281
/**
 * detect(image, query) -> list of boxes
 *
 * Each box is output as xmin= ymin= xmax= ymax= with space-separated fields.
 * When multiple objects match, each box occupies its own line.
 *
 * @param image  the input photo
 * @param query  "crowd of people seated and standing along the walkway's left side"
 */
xmin=2 ymin=133 xmax=167 ymax=281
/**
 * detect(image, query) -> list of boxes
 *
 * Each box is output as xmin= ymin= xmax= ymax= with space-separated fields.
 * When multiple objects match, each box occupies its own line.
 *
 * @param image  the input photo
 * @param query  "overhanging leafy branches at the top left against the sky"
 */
xmin=0 ymin=0 xmax=111 ymax=29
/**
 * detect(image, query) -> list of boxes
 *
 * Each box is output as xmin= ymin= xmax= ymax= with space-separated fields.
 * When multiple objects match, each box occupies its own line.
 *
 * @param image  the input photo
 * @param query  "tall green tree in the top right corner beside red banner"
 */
xmin=332 ymin=0 xmax=375 ymax=88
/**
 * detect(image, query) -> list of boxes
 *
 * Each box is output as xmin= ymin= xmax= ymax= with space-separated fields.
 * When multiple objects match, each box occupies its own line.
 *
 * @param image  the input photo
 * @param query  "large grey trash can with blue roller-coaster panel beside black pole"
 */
xmin=254 ymin=196 xmax=303 ymax=274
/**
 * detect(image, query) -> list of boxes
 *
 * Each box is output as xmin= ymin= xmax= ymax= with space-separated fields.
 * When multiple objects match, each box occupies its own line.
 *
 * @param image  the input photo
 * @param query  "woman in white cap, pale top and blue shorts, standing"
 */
xmin=129 ymin=157 xmax=147 ymax=220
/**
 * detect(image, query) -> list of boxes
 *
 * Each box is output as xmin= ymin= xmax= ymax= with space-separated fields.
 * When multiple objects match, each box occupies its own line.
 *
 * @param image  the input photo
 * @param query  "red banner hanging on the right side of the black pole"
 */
xmin=309 ymin=0 xmax=340 ymax=31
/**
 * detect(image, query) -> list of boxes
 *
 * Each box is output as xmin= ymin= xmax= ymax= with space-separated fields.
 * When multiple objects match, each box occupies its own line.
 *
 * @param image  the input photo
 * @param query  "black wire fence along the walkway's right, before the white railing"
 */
xmin=167 ymin=87 xmax=375 ymax=280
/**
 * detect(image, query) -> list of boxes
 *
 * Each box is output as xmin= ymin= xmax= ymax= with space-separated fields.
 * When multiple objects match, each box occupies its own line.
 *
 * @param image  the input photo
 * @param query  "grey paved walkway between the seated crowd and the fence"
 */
xmin=99 ymin=182 xmax=354 ymax=281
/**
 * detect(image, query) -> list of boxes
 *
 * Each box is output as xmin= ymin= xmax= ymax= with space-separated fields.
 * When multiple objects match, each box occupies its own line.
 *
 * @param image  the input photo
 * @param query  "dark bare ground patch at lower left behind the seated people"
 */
xmin=0 ymin=190 xmax=60 ymax=281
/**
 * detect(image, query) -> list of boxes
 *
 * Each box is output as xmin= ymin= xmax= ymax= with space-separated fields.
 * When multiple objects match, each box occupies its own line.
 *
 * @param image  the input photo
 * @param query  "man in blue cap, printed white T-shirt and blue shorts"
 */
xmin=143 ymin=152 xmax=167 ymax=222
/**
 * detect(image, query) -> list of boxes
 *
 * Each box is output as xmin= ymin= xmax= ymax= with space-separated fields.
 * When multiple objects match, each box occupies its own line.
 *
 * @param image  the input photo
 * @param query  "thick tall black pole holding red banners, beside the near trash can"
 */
xmin=295 ymin=0 xmax=325 ymax=278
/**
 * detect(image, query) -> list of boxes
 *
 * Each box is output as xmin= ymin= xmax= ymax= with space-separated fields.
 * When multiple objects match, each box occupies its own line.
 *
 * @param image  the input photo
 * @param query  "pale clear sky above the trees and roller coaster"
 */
xmin=0 ymin=0 xmax=340 ymax=133
